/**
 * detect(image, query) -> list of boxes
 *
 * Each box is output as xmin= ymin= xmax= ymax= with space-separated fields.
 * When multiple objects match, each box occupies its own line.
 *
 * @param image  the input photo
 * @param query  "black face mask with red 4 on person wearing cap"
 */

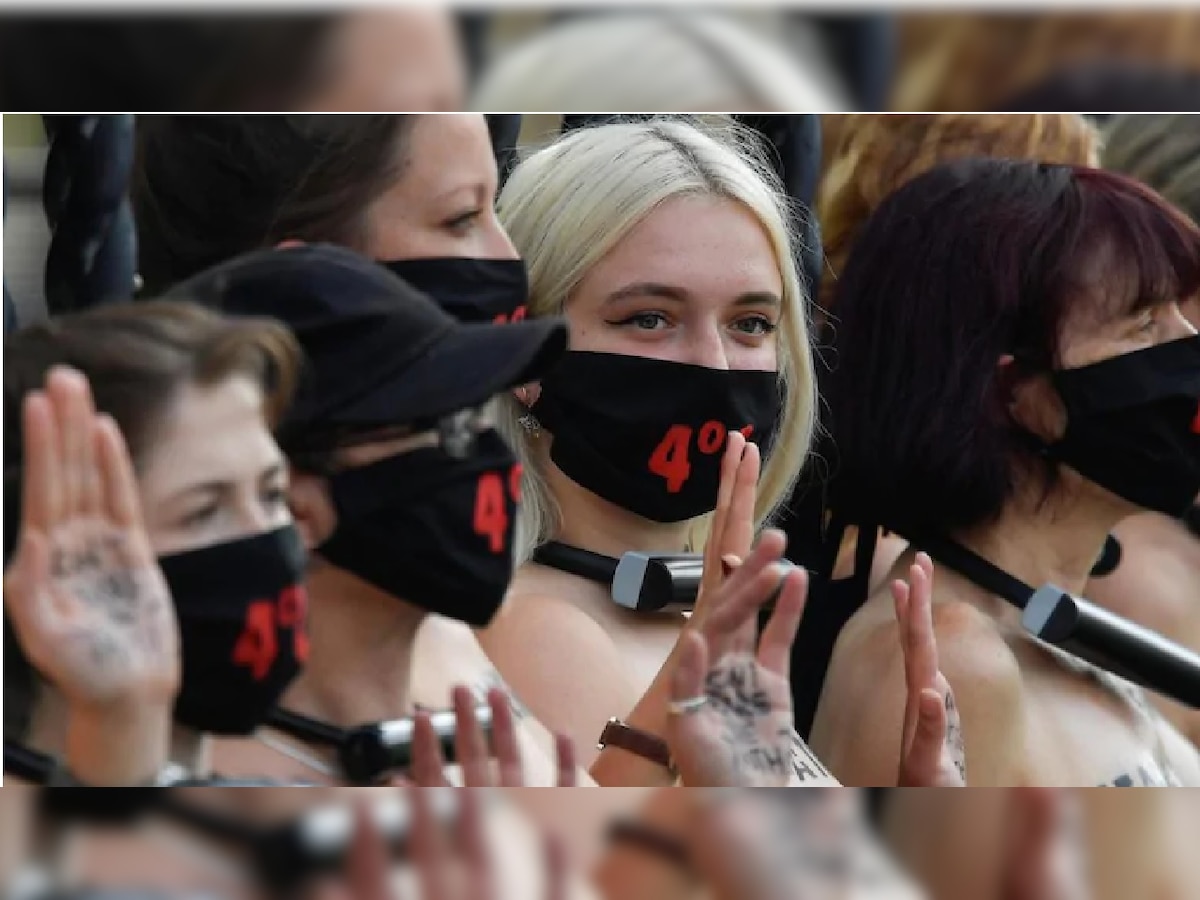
xmin=318 ymin=430 xmax=521 ymax=626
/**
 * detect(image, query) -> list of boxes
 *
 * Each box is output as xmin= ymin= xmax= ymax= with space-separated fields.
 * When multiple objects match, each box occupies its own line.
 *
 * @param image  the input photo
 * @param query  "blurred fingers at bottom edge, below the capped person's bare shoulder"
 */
xmin=410 ymin=685 xmax=576 ymax=787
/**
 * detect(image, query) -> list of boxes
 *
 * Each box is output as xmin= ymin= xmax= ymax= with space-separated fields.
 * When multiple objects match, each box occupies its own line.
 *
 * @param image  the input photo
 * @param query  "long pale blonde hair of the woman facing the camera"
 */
xmin=498 ymin=119 xmax=816 ymax=564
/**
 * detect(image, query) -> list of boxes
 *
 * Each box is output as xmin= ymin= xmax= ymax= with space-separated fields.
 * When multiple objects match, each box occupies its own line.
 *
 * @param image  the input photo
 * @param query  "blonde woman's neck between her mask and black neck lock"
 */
xmin=546 ymin=461 xmax=691 ymax=557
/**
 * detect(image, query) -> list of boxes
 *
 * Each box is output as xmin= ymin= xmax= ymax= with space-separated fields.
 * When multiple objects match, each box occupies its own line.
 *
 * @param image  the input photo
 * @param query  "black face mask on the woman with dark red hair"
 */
xmin=1049 ymin=337 xmax=1200 ymax=518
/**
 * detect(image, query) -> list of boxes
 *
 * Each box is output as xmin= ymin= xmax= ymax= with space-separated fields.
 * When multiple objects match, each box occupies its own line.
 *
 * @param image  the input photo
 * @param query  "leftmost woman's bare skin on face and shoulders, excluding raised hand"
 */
xmin=18 ymin=376 xmax=290 ymax=776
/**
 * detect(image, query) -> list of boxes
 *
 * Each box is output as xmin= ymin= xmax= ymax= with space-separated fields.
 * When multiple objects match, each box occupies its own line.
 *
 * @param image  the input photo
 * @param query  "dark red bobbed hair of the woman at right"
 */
xmin=826 ymin=160 xmax=1200 ymax=534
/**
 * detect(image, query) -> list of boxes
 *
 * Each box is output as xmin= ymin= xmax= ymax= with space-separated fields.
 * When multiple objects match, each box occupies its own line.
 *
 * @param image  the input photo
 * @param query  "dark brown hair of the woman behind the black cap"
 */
xmin=130 ymin=115 xmax=415 ymax=296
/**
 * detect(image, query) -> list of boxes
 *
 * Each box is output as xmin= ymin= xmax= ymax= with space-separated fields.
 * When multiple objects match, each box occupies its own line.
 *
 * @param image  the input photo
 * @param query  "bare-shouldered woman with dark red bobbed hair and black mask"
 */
xmin=812 ymin=160 xmax=1200 ymax=786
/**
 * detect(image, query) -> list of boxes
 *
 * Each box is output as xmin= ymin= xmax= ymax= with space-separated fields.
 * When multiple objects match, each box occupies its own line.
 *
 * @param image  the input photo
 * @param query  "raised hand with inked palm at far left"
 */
xmin=5 ymin=368 xmax=180 ymax=784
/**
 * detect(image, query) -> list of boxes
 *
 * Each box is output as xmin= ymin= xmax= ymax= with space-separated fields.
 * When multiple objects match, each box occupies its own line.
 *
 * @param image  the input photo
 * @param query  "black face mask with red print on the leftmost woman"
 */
xmin=158 ymin=526 xmax=308 ymax=734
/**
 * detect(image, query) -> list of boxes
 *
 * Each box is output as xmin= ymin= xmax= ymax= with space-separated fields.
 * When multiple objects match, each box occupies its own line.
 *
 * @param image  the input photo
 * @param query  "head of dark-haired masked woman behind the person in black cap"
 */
xmin=130 ymin=114 xmax=528 ymax=322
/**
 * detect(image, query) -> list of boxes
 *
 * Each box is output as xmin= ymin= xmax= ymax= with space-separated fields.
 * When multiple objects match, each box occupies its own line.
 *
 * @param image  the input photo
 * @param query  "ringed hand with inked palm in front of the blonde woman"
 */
xmin=666 ymin=542 xmax=808 ymax=787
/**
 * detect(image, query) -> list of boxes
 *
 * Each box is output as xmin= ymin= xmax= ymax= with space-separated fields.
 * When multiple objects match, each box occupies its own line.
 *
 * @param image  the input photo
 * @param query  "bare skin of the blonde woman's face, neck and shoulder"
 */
xmin=481 ymin=197 xmax=782 ymax=762
